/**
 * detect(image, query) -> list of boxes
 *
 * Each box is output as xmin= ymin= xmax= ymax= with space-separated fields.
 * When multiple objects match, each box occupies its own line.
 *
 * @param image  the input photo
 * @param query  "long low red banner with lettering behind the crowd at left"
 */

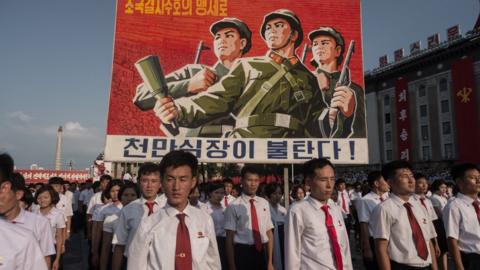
xmin=17 ymin=169 xmax=90 ymax=184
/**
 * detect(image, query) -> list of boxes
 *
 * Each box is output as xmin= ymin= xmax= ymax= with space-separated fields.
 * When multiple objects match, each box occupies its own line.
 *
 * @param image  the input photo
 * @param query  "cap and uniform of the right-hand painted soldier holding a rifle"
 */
xmin=308 ymin=27 xmax=367 ymax=138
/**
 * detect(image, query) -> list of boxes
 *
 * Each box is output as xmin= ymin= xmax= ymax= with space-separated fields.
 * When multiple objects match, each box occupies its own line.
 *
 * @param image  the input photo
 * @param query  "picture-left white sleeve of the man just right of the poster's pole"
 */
xmin=285 ymin=209 xmax=303 ymax=269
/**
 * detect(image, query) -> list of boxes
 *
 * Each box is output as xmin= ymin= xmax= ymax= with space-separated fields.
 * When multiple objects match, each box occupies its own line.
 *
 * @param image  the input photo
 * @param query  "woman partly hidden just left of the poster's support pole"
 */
xmin=265 ymin=183 xmax=286 ymax=270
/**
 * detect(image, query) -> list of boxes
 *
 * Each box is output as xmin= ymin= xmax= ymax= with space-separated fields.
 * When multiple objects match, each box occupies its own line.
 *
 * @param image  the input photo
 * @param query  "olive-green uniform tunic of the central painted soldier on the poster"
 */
xmin=176 ymin=52 xmax=325 ymax=138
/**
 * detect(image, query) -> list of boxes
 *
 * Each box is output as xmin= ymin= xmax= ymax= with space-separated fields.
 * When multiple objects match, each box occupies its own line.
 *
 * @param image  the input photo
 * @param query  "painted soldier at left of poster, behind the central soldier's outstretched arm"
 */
xmin=133 ymin=18 xmax=252 ymax=137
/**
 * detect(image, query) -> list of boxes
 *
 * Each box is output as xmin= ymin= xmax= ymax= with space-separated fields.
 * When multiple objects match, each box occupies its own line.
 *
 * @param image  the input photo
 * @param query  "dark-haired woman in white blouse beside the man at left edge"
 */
xmin=35 ymin=185 xmax=66 ymax=270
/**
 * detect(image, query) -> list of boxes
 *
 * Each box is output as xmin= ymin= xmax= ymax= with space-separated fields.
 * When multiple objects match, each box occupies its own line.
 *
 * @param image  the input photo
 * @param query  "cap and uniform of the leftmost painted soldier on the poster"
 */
xmin=133 ymin=18 xmax=252 ymax=137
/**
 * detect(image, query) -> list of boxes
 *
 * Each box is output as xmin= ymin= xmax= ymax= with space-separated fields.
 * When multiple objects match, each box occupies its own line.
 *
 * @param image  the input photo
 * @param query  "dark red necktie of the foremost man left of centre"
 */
xmin=175 ymin=213 xmax=192 ymax=270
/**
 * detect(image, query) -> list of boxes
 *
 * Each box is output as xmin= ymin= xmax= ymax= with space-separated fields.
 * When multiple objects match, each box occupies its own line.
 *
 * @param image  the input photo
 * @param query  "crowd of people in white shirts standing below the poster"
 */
xmin=0 ymin=151 xmax=480 ymax=270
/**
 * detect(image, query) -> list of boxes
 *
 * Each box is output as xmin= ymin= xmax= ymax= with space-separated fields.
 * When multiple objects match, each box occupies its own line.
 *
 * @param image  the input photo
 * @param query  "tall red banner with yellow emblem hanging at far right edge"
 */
xmin=452 ymin=57 xmax=480 ymax=163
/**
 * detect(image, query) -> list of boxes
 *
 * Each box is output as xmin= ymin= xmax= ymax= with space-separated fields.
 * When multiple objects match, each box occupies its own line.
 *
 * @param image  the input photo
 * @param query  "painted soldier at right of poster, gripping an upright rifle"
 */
xmin=308 ymin=27 xmax=366 ymax=138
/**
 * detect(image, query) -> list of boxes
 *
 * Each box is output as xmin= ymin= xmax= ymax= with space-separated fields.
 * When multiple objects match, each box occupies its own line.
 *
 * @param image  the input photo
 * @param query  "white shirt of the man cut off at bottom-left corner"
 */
xmin=0 ymin=219 xmax=47 ymax=270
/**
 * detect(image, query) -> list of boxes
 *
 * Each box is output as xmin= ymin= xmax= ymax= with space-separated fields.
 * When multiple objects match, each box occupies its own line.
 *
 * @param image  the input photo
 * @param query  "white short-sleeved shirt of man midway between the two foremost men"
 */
xmin=225 ymin=193 xmax=273 ymax=245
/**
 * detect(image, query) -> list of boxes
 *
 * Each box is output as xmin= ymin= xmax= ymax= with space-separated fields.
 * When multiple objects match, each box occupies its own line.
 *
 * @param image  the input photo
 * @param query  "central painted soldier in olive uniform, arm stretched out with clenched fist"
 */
xmin=154 ymin=9 xmax=326 ymax=138
